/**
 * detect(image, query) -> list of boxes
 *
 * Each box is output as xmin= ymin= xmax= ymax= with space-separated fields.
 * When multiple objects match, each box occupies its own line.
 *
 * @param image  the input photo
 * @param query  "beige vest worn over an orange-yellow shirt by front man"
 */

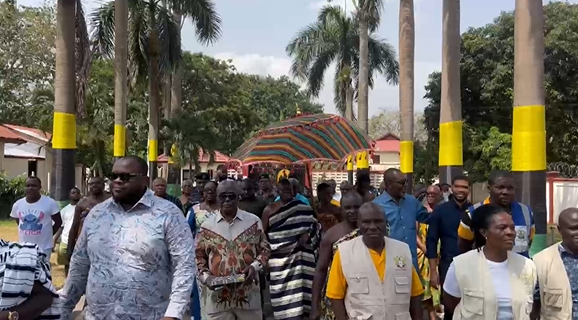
xmin=339 ymin=237 xmax=413 ymax=320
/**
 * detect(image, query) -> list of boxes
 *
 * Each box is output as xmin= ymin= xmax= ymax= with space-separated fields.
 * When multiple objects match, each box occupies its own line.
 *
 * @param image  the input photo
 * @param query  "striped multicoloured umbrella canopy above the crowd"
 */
xmin=231 ymin=113 xmax=374 ymax=165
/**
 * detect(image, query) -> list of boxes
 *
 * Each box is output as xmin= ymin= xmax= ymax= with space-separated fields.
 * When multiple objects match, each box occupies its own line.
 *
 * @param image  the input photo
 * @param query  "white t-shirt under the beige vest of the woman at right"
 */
xmin=444 ymin=259 xmax=514 ymax=320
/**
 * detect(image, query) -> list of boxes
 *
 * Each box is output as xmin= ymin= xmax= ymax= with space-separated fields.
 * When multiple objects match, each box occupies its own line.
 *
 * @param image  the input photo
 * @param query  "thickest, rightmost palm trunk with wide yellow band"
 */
xmin=512 ymin=0 xmax=547 ymax=255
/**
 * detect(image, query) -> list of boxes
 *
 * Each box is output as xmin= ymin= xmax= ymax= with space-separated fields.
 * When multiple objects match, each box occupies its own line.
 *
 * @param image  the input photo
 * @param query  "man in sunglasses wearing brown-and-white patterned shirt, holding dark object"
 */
xmin=195 ymin=180 xmax=271 ymax=320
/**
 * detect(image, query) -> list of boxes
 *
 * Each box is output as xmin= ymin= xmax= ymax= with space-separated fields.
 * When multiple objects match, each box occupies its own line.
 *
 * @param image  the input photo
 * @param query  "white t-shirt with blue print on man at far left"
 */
xmin=10 ymin=196 xmax=60 ymax=250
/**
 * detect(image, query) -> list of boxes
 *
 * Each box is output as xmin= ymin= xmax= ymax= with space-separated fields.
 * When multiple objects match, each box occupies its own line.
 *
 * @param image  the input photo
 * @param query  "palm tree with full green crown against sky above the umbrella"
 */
xmin=285 ymin=6 xmax=399 ymax=120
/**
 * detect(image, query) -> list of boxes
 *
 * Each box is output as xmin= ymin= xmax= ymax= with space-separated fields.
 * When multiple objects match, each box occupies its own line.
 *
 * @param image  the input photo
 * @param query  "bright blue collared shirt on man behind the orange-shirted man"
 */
xmin=373 ymin=192 xmax=429 ymax=266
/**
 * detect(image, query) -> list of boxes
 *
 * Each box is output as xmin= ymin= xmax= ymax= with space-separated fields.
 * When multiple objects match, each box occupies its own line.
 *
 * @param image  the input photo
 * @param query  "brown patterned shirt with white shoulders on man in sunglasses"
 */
xmin=195 ymin=209 xmax=271 ymax=313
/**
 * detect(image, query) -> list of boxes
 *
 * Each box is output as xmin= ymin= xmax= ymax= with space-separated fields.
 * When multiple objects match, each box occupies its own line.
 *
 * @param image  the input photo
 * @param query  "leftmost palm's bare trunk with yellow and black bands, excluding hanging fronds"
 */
xmin=50 ymin=0 xmax=76 ymax=206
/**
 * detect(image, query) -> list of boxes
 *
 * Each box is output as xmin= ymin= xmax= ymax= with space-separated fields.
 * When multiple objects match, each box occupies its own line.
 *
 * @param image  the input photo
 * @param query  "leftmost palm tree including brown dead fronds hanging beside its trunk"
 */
xmin=50 ymin=0 xmax=90 ymax=205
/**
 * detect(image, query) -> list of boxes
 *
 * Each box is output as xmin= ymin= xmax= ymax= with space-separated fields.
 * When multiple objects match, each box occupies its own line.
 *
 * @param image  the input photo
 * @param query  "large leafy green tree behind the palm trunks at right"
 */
xmin=424 ymin=2 xmax=578 ymax=178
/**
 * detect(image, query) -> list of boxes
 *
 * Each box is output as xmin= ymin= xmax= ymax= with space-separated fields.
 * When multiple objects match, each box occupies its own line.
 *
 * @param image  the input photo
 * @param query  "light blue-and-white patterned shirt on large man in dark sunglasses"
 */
xmin=62 ymin=190 xmax=196 ymax=320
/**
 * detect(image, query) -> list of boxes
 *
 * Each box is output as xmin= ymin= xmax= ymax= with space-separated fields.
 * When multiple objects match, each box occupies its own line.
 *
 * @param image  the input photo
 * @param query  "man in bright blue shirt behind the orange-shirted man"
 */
xmin=373 ymin=168 xmax=429 ymax=266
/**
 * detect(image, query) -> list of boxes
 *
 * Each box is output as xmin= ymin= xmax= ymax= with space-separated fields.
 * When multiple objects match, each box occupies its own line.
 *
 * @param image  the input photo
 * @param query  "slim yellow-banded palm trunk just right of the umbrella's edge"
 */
xmin=399 ymin=0 xmax=415 ymax=193
